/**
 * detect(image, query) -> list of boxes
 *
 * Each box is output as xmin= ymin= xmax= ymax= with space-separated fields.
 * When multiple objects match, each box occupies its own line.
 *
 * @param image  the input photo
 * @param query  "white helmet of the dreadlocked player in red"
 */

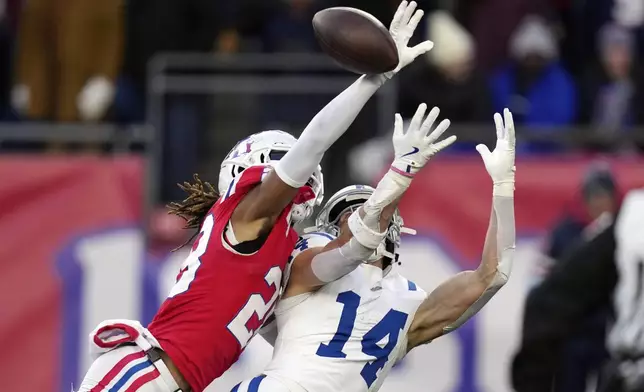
xmin=217 ymin=131 xmax=324 ymax=222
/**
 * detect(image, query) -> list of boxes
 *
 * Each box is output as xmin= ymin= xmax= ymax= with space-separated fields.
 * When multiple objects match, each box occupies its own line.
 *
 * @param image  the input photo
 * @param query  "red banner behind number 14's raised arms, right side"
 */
xmin=401 ymin=156 xmax=644 ymax=266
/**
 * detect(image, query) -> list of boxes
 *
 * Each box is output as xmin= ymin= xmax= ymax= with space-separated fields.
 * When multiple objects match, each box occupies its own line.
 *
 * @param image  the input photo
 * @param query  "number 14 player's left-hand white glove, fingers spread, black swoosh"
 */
xmin=392 ymin=103 xmax=456 ymax=177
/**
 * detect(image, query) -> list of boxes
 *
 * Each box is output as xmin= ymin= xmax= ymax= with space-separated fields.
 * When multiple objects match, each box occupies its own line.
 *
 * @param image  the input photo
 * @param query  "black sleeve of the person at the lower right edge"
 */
xmin=512 ymin=225 xmax=617 ymax=392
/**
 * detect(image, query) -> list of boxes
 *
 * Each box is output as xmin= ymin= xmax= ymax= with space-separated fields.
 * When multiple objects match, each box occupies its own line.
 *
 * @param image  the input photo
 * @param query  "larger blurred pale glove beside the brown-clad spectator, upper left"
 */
xmin=76 ymin=76 xmax=114 ymax=121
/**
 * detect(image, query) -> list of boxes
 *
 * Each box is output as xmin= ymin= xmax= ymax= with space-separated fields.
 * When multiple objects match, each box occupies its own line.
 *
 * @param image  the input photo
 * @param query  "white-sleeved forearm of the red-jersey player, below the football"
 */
xmin=275 ymin=75 xmax=385 ymax=188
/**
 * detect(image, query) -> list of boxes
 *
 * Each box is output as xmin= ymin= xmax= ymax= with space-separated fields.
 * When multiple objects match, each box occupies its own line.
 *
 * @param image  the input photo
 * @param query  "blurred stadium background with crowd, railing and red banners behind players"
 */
xmin=0 ymin=0 xmax=644 ymax=392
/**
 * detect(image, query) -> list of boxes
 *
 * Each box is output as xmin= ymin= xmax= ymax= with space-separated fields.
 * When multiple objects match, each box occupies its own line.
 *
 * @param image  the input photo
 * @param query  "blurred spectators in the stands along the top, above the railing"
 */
xmin=0 ymin=0 xmax=644 ymax=134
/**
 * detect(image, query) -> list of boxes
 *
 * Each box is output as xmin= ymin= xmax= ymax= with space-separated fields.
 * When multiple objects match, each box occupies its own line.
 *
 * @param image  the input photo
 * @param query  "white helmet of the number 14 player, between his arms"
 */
xmin=315 ymin=185 xmax=416 ymax=261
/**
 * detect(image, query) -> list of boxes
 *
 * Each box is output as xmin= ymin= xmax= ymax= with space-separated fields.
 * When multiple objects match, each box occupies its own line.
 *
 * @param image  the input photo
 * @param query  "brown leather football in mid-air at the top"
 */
xmin=313 ymin=7 xmax=398 ymax=74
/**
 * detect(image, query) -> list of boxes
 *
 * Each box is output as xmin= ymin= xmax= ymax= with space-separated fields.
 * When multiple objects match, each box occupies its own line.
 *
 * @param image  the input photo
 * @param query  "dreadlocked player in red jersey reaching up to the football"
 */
xmin=80 ymin=1 xmax=433 ymax=392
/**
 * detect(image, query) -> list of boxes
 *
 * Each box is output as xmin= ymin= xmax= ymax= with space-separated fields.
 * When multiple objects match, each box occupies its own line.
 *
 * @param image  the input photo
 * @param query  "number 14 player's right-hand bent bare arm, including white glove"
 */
xmin=407 ymin=109 xmax=515 ymax=350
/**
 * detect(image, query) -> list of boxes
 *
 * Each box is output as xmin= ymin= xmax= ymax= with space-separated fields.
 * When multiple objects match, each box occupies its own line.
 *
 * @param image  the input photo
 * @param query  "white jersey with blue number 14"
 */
xmin=264 ymin=233 xmax=427 ymax=392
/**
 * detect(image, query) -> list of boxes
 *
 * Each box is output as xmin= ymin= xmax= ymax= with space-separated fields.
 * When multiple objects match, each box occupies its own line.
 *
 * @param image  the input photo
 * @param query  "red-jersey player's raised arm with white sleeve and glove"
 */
xmin=232 ymin=1 xmax=433 ymax=241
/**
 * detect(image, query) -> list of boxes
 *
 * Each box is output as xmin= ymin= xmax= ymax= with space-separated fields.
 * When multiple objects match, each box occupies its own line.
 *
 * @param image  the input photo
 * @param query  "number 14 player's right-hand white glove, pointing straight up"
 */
xmin=476 ymin=109 xmax=516 ymax=197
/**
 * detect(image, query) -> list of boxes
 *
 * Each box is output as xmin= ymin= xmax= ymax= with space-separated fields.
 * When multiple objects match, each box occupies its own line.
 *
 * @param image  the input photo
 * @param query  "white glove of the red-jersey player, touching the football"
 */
xmin=384 ymin=0 xmax=434 ymax=79
